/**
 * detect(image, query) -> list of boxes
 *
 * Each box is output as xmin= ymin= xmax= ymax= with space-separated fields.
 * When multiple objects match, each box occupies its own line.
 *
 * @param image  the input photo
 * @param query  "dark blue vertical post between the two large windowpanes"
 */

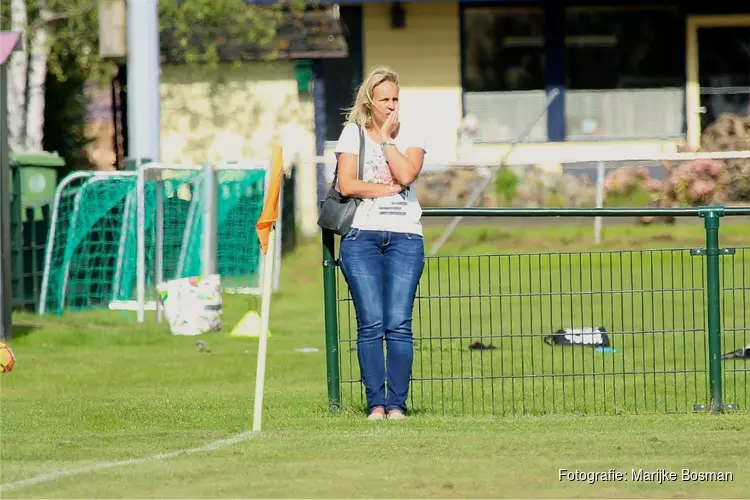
xmin=544 ymin=0 xmax=566 ymax=142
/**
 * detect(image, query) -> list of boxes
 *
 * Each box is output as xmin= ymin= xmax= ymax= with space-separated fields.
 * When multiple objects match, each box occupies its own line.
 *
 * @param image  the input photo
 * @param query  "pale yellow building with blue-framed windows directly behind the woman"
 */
xmin=317 ymin=0 xmax=750 ymax=162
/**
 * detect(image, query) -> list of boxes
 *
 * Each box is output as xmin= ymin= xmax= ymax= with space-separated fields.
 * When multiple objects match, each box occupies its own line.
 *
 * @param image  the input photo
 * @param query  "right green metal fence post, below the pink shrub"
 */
xmin=700 ymin=207 xmax=724 ymax=413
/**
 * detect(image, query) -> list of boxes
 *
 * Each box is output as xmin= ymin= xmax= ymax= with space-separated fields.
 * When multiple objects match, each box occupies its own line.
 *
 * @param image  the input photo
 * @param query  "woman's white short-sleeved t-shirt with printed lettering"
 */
xmin=335 ymin=123 xmax=425 ymax=235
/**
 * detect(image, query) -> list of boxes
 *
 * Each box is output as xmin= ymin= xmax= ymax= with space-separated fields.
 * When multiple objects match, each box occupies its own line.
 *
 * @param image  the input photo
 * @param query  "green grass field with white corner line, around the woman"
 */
xmin=0 ymin=221 xmax=750 ymax=498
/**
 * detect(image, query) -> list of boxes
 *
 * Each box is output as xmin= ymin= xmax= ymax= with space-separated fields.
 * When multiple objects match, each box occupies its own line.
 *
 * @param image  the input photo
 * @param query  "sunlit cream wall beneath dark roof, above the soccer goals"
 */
xmin=161 ymin=61 xmax=315 ymax=163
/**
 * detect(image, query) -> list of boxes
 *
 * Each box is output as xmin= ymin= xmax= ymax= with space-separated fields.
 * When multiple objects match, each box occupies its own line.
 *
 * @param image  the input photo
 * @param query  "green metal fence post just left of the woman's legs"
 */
xmin=322 ymin=231 xmax=341 ymax=411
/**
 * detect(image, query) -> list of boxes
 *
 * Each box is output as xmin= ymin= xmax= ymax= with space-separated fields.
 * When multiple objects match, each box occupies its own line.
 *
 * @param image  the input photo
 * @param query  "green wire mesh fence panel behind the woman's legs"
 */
xmin=324 ymin=209 xmax=750 ymax=415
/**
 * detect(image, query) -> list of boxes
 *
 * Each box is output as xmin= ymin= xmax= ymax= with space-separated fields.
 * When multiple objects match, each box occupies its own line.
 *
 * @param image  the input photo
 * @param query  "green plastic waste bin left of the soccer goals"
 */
xmin=9 ymin=152 xmax=66 ymax=311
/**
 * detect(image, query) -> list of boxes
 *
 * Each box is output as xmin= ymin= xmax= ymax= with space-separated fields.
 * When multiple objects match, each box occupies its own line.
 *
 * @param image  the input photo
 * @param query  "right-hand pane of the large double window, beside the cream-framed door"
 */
xmin=565 ymin=6 xmax=685 ymax=139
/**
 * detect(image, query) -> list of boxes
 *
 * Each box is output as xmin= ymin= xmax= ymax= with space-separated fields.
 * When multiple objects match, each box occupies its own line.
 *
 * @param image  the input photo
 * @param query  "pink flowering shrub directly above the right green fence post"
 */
xmin=665 ymin=160 xmax=731 ymax=206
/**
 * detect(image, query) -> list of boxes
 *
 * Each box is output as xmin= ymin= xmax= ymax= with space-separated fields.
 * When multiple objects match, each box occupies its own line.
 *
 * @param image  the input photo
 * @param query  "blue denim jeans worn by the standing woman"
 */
xmin=339 ymin=228 xmax=424 ymax=412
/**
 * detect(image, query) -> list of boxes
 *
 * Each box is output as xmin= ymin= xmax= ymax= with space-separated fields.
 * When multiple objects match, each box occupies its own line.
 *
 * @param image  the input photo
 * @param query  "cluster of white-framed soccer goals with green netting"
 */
xmin=39 ymin=160 xmax=281 ymax=322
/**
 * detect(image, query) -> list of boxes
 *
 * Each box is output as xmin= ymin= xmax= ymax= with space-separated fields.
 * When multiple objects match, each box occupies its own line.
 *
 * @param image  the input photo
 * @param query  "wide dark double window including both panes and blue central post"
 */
xmin=462 ymin=3 xmax=685 ymax=142
